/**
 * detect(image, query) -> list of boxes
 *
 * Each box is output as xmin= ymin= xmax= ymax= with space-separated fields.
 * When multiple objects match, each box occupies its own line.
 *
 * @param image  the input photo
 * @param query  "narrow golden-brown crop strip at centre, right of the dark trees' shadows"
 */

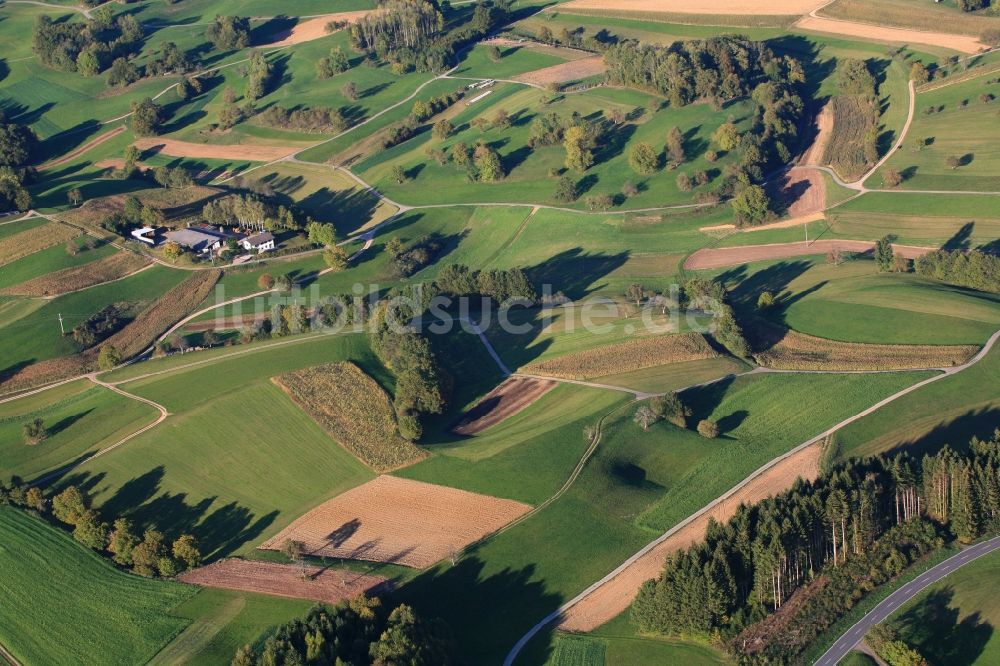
xmin=519 ymin=333 xmax=719 ymax=380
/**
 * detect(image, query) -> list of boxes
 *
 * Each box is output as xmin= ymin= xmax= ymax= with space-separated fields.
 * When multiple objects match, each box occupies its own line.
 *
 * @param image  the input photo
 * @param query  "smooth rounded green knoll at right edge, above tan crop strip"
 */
xmin=723 ymin=260 xmax=1000 ymax=344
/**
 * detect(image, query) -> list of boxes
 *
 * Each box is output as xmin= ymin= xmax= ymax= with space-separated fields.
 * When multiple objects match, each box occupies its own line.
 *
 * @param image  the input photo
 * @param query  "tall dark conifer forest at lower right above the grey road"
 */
xmin=632 ymin=431 xmax=1000 ymax=663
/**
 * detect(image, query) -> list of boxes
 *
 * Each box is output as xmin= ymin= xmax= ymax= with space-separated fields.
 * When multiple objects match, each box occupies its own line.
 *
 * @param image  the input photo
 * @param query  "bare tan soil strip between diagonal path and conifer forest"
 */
xmin=559 ymin=444 xmax=822 ymax=631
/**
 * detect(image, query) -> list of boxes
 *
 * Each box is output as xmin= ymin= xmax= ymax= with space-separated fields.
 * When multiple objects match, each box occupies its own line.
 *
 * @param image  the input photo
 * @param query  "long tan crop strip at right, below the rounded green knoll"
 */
xmin=755 ymin=330 xmax=979 ymax=371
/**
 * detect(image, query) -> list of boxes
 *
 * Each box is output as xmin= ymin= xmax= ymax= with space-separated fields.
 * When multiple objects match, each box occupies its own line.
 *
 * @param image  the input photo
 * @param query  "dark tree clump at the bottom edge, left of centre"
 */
xmin=232 ymin=595 xmax=455 ymax=666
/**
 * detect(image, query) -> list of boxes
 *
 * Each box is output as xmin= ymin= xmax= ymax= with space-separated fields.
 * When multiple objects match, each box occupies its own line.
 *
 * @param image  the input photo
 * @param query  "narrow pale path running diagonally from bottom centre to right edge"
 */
xmin=503 ymin=329 xmax=1000 ymax=666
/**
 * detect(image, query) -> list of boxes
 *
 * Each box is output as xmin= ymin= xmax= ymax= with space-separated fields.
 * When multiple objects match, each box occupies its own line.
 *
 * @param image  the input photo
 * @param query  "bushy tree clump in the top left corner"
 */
xmin=31 ymin=6 xmax=143 ymax=76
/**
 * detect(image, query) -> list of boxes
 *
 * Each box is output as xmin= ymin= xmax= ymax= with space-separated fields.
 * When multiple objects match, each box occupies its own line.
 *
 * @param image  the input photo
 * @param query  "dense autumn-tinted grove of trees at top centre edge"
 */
xmin=350 ymin=0 xmax=510 ymax=72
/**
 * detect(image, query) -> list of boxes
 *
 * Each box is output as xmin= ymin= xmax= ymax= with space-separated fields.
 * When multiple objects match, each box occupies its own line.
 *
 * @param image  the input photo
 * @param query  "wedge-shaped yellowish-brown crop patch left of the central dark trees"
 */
xmin=273 ymin=362 xmax=426 ymax=471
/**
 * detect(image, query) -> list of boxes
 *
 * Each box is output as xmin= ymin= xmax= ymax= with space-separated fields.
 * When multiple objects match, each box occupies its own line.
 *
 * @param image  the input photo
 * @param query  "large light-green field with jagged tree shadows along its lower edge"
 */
xmin=61 ymin=336 xmax=384 ymax=557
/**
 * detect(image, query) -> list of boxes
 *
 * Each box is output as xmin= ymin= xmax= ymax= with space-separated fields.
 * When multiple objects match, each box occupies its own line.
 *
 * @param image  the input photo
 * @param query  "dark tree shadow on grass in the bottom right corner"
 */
xmin=894 ymin=585 xmax=993 ymax=666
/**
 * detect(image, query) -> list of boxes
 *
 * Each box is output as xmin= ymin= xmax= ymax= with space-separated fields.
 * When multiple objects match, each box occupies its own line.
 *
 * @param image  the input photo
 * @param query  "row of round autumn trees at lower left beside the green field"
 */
xmin=0 ymin=477 xmax=201 ymax=578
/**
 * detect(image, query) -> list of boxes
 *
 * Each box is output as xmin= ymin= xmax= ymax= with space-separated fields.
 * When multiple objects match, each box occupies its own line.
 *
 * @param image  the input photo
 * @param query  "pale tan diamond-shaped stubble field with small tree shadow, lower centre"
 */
xmin=260 ymin=476 xmax=531 ymax=569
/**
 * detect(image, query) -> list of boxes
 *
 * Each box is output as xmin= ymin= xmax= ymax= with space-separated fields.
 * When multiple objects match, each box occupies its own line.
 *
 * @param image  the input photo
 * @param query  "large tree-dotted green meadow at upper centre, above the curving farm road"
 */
xmin=357 ymin=84 xmax=750 ymax=208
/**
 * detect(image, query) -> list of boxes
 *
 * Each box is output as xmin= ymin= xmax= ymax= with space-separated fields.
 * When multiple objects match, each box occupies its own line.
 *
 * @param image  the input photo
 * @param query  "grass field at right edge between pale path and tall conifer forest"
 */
xmin=835 ymin=338 xmax=1000 ymax=458
